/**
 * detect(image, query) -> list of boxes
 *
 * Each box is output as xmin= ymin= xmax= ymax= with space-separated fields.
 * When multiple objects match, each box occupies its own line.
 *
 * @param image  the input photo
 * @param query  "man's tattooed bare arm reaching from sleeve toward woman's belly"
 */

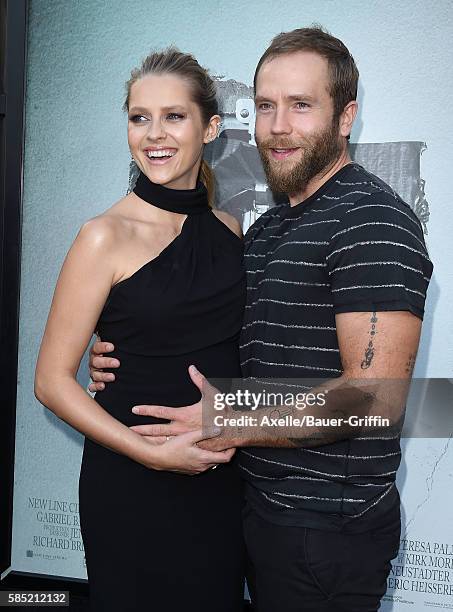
xmin=201 ymin=311 xmax=421 ymax=448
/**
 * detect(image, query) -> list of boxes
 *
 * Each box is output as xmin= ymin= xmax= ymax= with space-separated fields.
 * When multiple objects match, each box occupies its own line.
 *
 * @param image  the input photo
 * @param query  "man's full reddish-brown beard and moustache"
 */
xmin=257 ymin=122 xmax=342 ymax=195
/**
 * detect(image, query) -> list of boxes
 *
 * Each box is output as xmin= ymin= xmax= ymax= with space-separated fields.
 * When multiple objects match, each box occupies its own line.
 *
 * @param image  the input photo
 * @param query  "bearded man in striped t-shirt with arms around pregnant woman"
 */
xmin=88 ymin=28 xmax=432 ymax=612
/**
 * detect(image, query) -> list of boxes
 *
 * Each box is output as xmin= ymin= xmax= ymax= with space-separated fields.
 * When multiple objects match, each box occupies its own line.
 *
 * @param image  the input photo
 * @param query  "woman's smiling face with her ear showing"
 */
xmin=127 ymin=74 xmax=220 ymax=189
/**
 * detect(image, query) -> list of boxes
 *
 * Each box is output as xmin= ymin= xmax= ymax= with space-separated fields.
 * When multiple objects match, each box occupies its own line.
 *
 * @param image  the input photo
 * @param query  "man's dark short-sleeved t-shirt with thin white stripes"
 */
xmin=239 ymin=163 xmax=432 ymax=530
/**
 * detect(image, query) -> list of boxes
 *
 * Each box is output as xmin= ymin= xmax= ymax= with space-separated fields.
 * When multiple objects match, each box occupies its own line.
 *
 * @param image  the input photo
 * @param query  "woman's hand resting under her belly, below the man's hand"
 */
xmin=140 ymin=430 xmax=236 ymax=476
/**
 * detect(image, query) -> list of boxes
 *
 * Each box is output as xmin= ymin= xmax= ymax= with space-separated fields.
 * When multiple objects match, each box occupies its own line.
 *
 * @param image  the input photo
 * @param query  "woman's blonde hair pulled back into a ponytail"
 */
xmin=123 ymin=47 xmax=219 ymax=206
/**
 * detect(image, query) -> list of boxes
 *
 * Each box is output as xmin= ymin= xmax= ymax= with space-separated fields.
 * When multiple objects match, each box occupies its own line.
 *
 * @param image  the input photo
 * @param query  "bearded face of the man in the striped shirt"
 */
xmin=255 ymin=51 xmax=344 ymax=195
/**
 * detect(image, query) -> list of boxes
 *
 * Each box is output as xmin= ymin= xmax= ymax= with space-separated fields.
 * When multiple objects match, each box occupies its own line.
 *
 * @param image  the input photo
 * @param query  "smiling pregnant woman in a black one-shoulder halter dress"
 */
xmin=35 ymin=48 xmax=245 ymax=612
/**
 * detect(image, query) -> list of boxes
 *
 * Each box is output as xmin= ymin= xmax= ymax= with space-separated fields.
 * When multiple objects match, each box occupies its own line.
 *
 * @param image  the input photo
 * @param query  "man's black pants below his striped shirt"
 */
xmin=244 ymin=507 xmax=400 ymax=612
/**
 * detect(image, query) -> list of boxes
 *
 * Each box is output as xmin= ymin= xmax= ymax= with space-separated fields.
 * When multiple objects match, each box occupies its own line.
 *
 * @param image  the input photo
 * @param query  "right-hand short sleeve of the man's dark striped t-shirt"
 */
xmin=326 ymin=193 xmax=433 ymax=319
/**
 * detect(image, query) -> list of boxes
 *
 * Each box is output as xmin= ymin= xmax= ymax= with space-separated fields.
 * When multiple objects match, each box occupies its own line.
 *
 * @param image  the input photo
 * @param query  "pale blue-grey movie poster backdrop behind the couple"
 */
xmin=12 ymin=0 xmax=453 ymax=612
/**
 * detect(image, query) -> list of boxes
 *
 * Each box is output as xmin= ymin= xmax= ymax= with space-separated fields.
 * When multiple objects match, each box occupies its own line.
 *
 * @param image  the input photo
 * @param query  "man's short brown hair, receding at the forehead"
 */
xmin=253 ymin=25 xmax=359 ymax=119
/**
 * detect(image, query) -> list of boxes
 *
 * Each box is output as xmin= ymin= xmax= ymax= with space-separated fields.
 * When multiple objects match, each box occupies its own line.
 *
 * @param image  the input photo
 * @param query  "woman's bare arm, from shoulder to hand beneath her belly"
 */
xmin=35 ymin=217 xmax=230 ymax=473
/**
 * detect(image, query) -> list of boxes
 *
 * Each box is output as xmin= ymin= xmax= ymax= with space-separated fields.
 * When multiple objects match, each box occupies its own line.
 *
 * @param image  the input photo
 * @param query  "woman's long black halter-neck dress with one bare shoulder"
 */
xmin=79 ymin=175 xmax=245 ymax=612
